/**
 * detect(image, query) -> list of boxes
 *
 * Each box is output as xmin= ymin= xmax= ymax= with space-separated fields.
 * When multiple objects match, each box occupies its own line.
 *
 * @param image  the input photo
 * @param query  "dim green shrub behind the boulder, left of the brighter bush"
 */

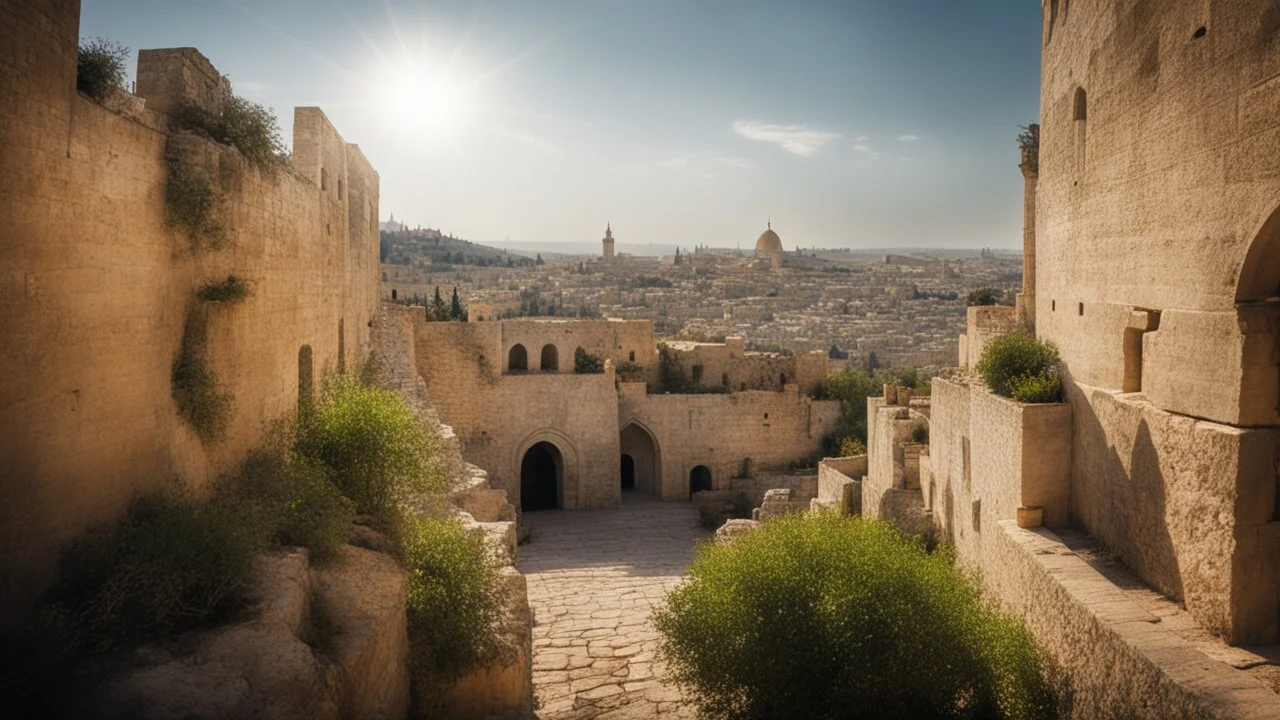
xmin=227 ymin=446 xmax=355 ymax=561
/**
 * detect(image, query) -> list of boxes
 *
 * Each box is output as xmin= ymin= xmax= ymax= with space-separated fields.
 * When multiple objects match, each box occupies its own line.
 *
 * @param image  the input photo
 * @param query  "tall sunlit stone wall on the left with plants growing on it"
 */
xmin=0 ymin=0 xmax=378 ymax=616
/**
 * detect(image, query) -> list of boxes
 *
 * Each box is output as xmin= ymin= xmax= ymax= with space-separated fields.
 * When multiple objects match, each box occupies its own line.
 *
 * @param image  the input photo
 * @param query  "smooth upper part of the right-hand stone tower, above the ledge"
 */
xmin=1036 ymin=0 xmax=1280 ymax=424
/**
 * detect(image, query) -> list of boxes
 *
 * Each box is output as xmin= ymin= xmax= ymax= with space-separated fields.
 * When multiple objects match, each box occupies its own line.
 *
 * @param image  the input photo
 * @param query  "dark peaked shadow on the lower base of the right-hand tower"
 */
xmin=1064 ymin=380 xmax=1182 ymax=601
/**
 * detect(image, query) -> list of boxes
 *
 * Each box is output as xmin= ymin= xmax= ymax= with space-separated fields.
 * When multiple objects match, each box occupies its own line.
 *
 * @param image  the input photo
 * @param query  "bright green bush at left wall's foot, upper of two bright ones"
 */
xmin=294 ymin=375 xmax=447 ymax=525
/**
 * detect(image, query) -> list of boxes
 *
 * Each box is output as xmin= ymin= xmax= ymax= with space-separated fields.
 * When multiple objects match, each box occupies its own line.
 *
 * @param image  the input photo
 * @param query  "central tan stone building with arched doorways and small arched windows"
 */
xmin=398 ymin=309 xmax=840 ymax=510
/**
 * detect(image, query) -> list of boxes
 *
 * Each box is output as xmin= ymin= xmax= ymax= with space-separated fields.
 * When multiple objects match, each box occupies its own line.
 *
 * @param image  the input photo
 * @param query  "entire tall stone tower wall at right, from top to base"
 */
xmin=1036 ymin=0 xmax=1280 ymax=642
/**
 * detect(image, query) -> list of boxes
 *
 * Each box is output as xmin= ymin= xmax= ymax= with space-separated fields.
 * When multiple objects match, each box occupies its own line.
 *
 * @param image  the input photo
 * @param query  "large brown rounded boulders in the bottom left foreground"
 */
xmin=89 ymin=546 xmax=410 ymax=720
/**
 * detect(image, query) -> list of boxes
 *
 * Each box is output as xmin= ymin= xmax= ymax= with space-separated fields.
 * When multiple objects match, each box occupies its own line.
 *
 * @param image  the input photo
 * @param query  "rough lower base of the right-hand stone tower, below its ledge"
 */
xmin=1070 ymin=384 xmax=1280 ymax=644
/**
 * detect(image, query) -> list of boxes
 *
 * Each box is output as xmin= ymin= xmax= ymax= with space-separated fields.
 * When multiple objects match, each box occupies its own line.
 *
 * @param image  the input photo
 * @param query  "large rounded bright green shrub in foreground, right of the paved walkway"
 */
xmin=654 ymin=514 xmax=1055 ymax=720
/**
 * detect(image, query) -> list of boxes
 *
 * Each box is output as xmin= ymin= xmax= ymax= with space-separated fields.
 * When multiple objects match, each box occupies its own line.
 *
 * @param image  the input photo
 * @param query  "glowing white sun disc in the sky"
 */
xmin=381 ymin=61 xmax=468 ymax=141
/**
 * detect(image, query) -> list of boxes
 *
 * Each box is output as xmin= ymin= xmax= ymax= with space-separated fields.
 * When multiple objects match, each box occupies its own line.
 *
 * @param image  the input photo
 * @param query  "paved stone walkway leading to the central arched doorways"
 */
xmin=518 ymin=492 xmax=708 ymax=720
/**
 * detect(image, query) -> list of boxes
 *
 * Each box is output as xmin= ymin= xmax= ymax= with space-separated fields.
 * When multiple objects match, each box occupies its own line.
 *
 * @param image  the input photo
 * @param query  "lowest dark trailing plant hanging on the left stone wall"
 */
xmin=169 ymin=310 xmax=232 ymax=442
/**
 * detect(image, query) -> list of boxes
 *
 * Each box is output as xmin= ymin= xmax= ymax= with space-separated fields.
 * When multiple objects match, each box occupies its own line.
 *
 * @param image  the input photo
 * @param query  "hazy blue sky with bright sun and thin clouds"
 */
xmin=81 ymin=0 xmax=1041 ymax=250
